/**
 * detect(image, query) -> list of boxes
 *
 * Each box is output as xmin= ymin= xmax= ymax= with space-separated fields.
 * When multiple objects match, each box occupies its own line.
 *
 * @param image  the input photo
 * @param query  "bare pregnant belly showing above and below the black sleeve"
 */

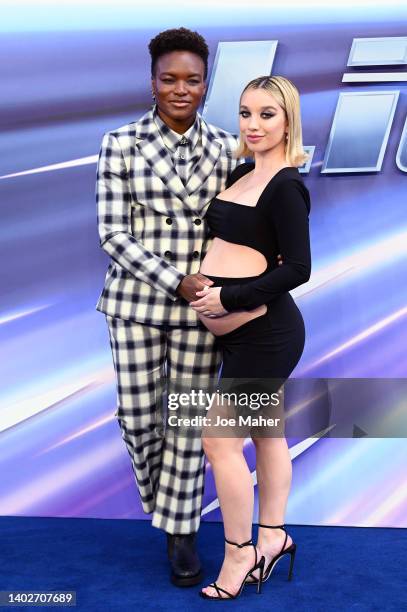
xmin=198 ymin=238 xmax=267 ymax=336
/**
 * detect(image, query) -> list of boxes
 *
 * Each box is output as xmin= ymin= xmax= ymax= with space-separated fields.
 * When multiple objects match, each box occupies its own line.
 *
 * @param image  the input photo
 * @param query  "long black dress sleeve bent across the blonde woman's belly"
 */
xmin=220 ymin=178 xmax=311 ymax=312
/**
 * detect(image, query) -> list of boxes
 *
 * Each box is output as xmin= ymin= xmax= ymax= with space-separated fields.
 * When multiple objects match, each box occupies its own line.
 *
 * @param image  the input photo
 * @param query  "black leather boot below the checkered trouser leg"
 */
xmin=167 ymin=533 xmax=202 ymax=587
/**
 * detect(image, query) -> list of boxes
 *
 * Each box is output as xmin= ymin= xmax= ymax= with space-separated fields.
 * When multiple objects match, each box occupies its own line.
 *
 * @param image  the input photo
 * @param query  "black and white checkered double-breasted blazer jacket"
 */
xmin=96 ymin=109 xmax=237 ymax=326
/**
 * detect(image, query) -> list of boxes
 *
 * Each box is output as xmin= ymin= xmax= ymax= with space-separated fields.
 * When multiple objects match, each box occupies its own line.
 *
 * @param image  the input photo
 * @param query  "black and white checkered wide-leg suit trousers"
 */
xmin=106 ymin=316 xmax=221 ymax=534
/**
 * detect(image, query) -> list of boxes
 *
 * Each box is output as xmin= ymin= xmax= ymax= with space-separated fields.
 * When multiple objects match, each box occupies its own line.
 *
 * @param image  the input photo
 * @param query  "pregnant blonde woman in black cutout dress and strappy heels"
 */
xmin=191 ymin=76 xmax=311 ymax=599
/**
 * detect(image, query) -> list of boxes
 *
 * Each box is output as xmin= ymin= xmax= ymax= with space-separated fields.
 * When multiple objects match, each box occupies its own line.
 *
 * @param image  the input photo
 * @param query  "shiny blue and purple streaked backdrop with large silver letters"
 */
xmin=0 ymin=0 xmax=407 ymax=527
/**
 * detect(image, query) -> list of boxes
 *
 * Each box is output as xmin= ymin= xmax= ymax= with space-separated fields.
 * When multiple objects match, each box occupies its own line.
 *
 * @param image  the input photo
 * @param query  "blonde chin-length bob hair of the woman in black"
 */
xmin=234 ymin=76 xmax=309 ymax=167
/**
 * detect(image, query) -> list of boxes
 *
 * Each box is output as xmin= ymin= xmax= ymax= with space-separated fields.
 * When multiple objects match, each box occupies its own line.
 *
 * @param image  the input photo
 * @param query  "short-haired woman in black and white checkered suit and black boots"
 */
xmin=97 ymin=28 xmax=241 ymax=586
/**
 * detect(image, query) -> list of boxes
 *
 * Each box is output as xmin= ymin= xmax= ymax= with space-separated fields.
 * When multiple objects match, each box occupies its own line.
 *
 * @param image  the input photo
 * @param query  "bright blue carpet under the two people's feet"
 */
xmin=0 ymin=517 xmax=407 ymax=612
